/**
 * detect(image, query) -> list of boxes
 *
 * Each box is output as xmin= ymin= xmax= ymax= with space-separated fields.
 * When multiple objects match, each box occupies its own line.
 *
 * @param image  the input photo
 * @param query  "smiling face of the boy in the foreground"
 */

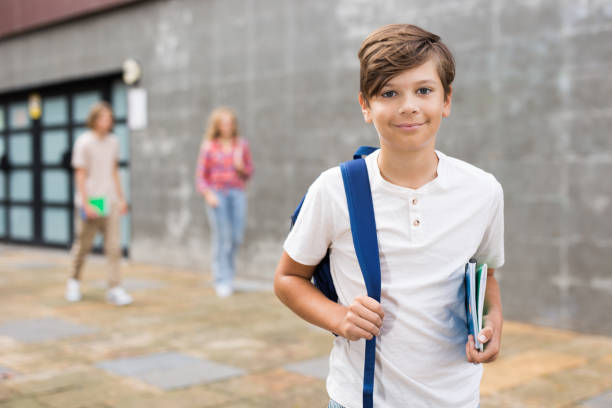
xmin=359 ymin=59 xmax=451 ymax=156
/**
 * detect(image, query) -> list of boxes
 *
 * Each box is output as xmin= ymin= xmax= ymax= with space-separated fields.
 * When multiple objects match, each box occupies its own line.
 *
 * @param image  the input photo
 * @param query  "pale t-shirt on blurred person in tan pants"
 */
xmin=72 ymin=131 xmax=119 ymax=207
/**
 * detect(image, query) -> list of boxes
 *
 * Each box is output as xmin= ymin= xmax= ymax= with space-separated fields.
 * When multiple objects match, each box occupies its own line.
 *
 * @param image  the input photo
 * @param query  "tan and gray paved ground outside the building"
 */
xmin=0 ymin=247 xmax=612 ymax=408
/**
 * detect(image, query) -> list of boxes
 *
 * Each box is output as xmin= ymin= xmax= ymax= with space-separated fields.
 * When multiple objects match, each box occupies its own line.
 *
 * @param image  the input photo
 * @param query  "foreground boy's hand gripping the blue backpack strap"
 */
xmin=337 ymin=295 xmax=385 ymax=341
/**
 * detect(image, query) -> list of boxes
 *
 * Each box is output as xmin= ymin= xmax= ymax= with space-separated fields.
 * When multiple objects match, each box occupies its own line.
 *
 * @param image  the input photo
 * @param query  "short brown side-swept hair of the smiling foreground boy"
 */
xmin=358 ymin=24 xmax=455 ymax=102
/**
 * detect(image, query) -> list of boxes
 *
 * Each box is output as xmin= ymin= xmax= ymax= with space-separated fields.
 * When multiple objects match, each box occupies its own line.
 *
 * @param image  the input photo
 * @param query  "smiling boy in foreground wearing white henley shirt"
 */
xmin=274 ymin=24 xmax=504 ymax=408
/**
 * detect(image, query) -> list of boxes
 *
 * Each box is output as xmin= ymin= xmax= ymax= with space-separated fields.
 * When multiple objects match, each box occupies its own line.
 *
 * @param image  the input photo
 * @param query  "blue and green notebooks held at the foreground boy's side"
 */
xmin=465 ymin=259 xmax=487 ymax=351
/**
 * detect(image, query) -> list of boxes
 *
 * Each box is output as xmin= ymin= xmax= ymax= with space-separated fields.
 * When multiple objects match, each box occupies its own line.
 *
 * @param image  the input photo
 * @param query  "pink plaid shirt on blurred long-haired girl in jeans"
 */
xmin=196 ymin=139 xmax=253 ymax=193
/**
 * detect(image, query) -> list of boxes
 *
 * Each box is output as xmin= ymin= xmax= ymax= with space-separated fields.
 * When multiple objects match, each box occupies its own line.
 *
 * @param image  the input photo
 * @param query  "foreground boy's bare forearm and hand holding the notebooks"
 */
xmin=465 ymin=268 xmax=504 ymax=363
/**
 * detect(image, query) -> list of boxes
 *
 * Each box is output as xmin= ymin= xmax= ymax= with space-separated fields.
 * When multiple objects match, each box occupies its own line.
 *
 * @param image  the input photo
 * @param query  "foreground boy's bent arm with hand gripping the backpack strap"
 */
xmin=274 ymin=251 xmax=384 ymax=340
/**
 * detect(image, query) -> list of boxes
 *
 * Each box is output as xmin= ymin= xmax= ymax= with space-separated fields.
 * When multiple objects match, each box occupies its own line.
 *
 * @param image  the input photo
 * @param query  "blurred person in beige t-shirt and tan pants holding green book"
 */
xmin=65 ymin=102 xmax=132 ymax=306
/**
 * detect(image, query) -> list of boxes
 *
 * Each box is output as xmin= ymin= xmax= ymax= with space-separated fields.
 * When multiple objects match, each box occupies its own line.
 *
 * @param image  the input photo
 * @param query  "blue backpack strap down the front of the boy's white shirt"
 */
xmin=340 ymin=158 xmax=380 ymax=408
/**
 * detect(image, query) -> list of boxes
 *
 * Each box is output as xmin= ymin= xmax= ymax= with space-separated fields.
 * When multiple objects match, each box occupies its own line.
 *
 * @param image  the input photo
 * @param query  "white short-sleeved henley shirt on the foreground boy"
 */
xmin=284 ymin=151 xmax=504 ymax=408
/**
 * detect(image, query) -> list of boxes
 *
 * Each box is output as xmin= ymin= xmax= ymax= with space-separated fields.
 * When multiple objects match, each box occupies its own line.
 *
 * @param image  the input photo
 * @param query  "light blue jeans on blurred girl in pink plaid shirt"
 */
xmin=207 ymin=189 xmax=246 ymax=286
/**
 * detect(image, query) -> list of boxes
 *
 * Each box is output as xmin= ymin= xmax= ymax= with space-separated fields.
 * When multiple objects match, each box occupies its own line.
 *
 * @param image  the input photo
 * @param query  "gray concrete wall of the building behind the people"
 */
xmin=0 ymin=0 xmax=612 ymax=334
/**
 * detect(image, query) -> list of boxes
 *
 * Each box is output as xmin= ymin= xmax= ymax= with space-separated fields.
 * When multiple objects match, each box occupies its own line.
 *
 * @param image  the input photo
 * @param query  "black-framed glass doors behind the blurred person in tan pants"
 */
xmin=0 ymin=78 xmax=130 ymax=254
